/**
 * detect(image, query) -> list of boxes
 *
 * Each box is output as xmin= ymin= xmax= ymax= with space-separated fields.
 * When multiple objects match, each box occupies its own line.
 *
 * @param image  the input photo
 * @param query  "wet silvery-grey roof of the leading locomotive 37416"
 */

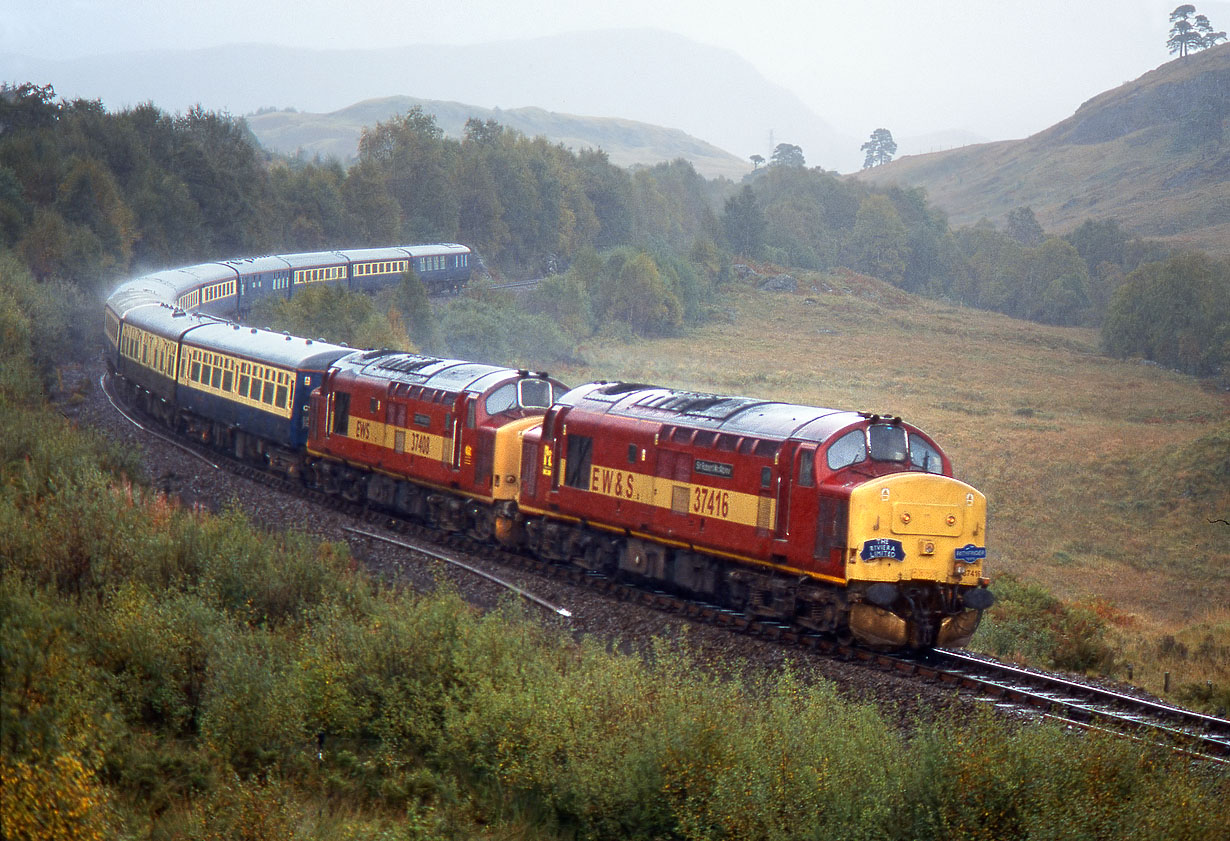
xmin=558 ymin=382 xmax=863 ymax=441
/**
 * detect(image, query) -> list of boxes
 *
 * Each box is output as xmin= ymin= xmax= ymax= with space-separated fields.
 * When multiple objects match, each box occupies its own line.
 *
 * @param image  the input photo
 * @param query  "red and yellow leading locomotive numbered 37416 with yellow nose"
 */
xmin=519 ymin=382 xmax=993 ymax=648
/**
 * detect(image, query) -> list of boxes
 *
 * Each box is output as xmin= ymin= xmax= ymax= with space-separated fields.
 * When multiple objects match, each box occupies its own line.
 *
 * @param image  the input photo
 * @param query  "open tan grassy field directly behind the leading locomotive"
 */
xmin=548 ymin=273 xmax=1230 ymax=677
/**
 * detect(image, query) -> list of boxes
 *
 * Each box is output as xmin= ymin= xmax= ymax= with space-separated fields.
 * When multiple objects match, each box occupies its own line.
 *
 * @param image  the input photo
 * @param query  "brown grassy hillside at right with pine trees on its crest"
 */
xmin=857 ymin=44 xmax=1230 ymax=255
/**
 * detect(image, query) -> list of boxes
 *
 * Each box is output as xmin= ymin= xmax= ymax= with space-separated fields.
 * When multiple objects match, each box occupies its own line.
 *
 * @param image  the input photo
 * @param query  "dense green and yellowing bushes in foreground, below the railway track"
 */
xmin=0 ymin=275 xmax=1230 ymax=841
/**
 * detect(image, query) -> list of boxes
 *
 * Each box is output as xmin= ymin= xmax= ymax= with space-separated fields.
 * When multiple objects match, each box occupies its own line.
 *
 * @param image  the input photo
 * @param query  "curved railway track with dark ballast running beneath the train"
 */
xmin=100 ymin=377 xmax=1230 ymax=765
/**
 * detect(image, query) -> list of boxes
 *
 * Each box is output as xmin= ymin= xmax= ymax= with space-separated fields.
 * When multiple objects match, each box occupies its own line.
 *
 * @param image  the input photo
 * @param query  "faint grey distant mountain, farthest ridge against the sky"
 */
xmin=0 ymin=30 xmax=862 ymax=171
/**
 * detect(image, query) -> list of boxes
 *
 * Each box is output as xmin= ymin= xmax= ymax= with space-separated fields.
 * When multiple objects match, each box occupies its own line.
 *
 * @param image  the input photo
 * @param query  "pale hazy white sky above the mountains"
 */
xmin=0 ymin=0 xmax=1230 ymax=140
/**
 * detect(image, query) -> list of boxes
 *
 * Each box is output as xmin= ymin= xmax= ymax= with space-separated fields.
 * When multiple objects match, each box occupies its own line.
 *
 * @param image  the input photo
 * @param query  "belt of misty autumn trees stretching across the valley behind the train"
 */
xmin=0 ymin=84 xmax=1230 ymax=374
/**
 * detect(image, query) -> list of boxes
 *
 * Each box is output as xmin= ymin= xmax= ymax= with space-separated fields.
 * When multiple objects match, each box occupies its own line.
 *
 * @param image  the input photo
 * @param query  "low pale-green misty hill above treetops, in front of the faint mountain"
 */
xmin=246 ymin=96 xmax=752 ymax=181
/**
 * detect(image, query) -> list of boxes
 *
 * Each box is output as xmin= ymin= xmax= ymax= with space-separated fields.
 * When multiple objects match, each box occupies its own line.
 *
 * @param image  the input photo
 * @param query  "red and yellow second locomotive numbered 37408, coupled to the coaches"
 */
xmin=305 ymin=350 xmax=566 ymax=540
